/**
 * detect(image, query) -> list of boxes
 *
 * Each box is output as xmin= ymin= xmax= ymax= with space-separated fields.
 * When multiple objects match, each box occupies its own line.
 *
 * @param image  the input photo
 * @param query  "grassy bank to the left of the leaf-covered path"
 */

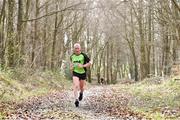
xmin=0 ymin=69 xmax=71 ymax=102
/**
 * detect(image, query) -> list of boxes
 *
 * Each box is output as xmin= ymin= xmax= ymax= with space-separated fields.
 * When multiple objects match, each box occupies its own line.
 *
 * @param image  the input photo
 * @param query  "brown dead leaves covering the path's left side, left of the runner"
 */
xmin=6 ymin=92 xmax=71 ymax=120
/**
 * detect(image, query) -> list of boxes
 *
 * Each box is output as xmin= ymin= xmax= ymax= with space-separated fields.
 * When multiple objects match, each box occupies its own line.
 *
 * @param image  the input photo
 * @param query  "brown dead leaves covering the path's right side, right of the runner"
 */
xmin=85 ymin=87 xmax=144 ymax=120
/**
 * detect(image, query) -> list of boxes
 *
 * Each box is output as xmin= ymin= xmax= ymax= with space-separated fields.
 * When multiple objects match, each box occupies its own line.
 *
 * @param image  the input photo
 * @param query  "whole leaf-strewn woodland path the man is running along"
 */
xmin=2 ymin=86 xmax=147 ymax=120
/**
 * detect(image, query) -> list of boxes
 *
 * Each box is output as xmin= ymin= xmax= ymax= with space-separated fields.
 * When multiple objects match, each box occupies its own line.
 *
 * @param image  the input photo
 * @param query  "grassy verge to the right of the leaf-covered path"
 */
xmin=116 ymin=77 xmax=180 ymax=120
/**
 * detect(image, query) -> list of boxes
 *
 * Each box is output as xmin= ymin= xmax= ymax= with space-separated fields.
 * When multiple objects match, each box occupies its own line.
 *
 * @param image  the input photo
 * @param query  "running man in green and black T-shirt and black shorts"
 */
xmin=70 ymin=43 xmax=91 ymax=107
